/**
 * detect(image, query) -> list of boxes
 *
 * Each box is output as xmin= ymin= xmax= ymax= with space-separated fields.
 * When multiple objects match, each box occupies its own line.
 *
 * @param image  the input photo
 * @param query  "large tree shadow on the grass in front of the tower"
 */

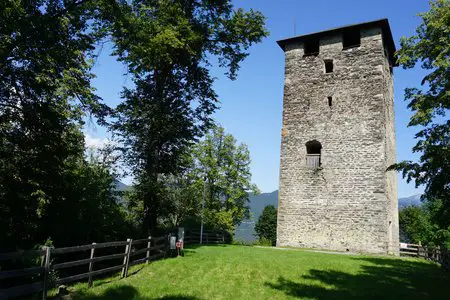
xmin=265 ymin=258 xmax=450 ymax=299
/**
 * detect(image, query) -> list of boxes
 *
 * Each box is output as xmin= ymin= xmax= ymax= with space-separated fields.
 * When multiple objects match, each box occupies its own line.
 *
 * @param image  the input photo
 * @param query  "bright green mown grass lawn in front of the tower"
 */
xmin=70 ymin=246 xmax=450 ymax=299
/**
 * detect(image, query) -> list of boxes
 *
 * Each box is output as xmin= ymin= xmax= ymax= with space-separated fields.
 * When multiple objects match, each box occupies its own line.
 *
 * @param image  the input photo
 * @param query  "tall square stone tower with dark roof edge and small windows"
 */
xmin=277 ymin=19 xmax=399 ymax=255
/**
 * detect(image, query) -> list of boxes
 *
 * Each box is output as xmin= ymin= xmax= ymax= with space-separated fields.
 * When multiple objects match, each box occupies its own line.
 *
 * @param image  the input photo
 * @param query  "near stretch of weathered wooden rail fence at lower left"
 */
xmin=0 ymin=236 xmax=167 ymax=299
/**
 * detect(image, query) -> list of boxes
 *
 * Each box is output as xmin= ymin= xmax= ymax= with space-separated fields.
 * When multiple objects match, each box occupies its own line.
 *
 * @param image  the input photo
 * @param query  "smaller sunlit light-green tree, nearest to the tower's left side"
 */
xmin=190 ymin=127 xmax=259 ymax=231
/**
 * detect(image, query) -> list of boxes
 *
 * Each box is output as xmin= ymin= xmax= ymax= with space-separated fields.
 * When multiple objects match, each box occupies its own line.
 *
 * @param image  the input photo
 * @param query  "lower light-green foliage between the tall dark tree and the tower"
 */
xmin=159 ymin=127 xmax=258 ymax=232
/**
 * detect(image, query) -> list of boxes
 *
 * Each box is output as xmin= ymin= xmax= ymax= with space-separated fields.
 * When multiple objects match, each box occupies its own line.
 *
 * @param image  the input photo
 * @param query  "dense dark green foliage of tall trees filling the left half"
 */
xmin=0 ymin=0 xmax=267 ymax=250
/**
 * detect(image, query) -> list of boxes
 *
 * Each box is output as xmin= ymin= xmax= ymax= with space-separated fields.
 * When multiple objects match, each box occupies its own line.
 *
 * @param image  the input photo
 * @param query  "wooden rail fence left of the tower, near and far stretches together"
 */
xmin=0 ymin=229 xmax=231 ymax=299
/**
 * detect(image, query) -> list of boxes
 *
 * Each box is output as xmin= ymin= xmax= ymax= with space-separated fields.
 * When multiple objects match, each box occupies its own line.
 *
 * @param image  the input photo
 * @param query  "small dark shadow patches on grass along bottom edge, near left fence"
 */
xmin=69 ymin=285 xmax=199 ymax=300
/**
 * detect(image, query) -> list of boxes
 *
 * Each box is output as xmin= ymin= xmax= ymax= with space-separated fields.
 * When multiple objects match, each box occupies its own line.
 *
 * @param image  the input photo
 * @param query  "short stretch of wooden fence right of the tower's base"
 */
xmin=400 ymin=243 xmax=450 ymax=270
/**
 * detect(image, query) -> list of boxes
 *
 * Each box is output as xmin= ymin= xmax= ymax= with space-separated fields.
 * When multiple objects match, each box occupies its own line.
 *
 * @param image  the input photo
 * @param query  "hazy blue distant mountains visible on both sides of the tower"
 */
xmin=234 ymin=190 xmax=421 ymax=242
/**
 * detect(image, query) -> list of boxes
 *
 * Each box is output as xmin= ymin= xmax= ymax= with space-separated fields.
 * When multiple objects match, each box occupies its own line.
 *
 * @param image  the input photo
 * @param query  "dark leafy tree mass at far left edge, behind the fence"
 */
xmin=0 ymin=0 xmax=121 ymax=250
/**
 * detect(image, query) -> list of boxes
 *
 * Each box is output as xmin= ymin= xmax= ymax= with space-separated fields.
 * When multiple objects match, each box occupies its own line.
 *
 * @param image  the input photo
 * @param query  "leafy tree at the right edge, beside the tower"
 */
xmin=391 ymin=0 xmax=450 ymax=229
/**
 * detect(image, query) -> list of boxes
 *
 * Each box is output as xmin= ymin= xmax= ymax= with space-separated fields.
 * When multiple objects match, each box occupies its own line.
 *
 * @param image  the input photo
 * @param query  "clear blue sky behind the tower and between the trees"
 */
xmin=85 ymin=0 xmax=428 ymax=197
